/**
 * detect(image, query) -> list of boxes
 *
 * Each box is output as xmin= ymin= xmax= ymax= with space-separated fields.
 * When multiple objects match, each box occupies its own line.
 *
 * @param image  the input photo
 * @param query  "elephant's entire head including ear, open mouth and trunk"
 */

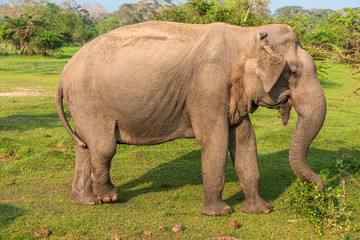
xmin=245 ymin=24 xmax=326 ymax=191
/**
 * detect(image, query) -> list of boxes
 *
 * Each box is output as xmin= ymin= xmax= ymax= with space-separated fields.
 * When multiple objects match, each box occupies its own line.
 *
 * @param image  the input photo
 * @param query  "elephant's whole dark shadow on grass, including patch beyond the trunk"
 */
xmin=117 ymin=148 xmax=360 ymax=206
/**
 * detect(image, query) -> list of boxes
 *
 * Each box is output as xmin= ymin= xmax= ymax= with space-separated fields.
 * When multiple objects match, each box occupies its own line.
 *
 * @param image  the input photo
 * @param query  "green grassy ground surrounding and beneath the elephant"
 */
xmin=0 ymin=48 xmax=360 ymax=239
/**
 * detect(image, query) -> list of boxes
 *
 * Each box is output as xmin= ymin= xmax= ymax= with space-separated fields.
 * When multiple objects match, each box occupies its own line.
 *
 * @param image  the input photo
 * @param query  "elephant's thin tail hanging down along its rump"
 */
xmin=55 ymin=83 xmax=86 ymax=148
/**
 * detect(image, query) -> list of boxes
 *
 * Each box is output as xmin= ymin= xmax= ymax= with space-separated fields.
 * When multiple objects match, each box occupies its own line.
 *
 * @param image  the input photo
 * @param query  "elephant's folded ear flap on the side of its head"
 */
xmin=257 ymin=32 xmax=286 ymax=92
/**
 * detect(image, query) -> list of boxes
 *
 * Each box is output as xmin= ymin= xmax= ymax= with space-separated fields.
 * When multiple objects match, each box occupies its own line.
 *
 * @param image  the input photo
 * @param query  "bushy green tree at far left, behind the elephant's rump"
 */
xmin=0 ymin=0 xmax=88 ymax=55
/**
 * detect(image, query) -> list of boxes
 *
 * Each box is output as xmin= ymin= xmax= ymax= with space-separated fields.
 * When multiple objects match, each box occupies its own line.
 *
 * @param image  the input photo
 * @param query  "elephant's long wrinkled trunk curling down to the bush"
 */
xmin=289 ymin=51 xmax=326 ymax=191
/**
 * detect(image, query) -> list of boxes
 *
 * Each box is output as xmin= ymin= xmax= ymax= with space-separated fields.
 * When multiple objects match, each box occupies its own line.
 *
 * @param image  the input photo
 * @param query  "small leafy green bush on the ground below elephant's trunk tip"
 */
xmin=289 ymin=179 xmax=353 ymax=236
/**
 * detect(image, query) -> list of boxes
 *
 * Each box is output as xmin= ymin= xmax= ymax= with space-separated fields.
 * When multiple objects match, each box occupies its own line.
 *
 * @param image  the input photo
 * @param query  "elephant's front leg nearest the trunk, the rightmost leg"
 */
xmin=229 ymin=116 xmax=272 ymax=213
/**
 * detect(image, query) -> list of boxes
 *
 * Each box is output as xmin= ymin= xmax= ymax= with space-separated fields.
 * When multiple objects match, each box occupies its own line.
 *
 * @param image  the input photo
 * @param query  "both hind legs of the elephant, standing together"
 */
xmin=72 ymin=118 xmax=118 ymax=205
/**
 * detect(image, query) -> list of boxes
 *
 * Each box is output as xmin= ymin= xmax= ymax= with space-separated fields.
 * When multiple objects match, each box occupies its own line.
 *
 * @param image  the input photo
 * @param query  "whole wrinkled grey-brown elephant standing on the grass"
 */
xmin=56 ymin=22 xmax=326 ymax=215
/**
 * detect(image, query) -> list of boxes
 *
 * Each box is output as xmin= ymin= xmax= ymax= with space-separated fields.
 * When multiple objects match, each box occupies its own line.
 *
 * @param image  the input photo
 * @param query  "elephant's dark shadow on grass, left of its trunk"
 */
xmin=118 ymin=150 xmax=296 ymax=206
